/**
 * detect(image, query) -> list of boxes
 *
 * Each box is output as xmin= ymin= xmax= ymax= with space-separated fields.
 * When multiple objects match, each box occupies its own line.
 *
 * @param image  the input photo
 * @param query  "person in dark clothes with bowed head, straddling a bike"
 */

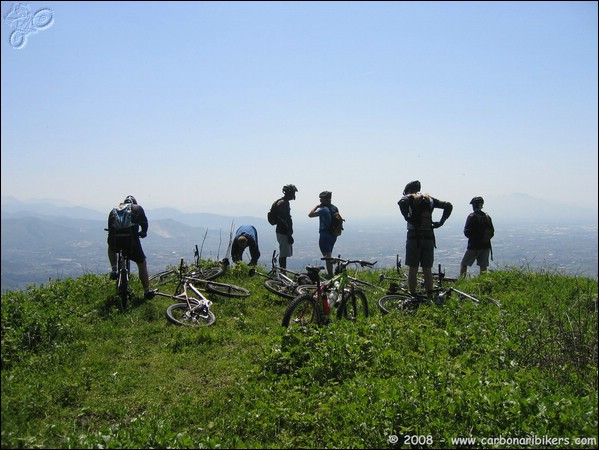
xmin=108 ymin=195 xmax=154 ymax=300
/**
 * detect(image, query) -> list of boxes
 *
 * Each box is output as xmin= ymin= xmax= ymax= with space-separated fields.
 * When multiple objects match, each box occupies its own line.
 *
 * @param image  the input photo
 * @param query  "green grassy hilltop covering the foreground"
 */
xmin=2 ymin=264 xmax=598 ymax=448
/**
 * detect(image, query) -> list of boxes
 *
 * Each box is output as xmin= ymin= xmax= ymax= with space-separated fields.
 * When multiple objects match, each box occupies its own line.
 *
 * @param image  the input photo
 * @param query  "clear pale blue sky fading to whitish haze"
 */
xmin=1 ymin=2 xmax=598 ymax=222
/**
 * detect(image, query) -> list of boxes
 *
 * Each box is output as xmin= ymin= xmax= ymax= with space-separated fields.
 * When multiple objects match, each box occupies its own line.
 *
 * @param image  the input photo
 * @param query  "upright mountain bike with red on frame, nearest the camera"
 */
xmin=282 ymin=257 xmax=376 ymax=327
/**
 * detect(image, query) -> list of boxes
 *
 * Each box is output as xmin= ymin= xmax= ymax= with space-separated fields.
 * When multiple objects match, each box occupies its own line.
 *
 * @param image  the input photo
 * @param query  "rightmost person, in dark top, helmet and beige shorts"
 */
xmin=460 ymin=197 xmax=495 ymax=277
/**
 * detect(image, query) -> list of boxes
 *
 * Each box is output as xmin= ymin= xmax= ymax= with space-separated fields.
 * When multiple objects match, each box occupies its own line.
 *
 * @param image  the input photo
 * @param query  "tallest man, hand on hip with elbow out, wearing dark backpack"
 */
xmin=397 ymin=180 xmax=453 ymax=297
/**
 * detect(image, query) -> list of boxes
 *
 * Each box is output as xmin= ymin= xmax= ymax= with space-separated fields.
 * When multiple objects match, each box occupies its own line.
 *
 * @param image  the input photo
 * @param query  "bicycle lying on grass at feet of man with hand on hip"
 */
xmin=377 ymin=264 xmax=501 ymax=314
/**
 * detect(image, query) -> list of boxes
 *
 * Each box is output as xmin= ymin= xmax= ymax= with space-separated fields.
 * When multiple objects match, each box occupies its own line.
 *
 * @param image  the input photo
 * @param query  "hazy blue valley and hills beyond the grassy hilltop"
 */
xmin=1 ymin=197 xmax=598 ymax=291
